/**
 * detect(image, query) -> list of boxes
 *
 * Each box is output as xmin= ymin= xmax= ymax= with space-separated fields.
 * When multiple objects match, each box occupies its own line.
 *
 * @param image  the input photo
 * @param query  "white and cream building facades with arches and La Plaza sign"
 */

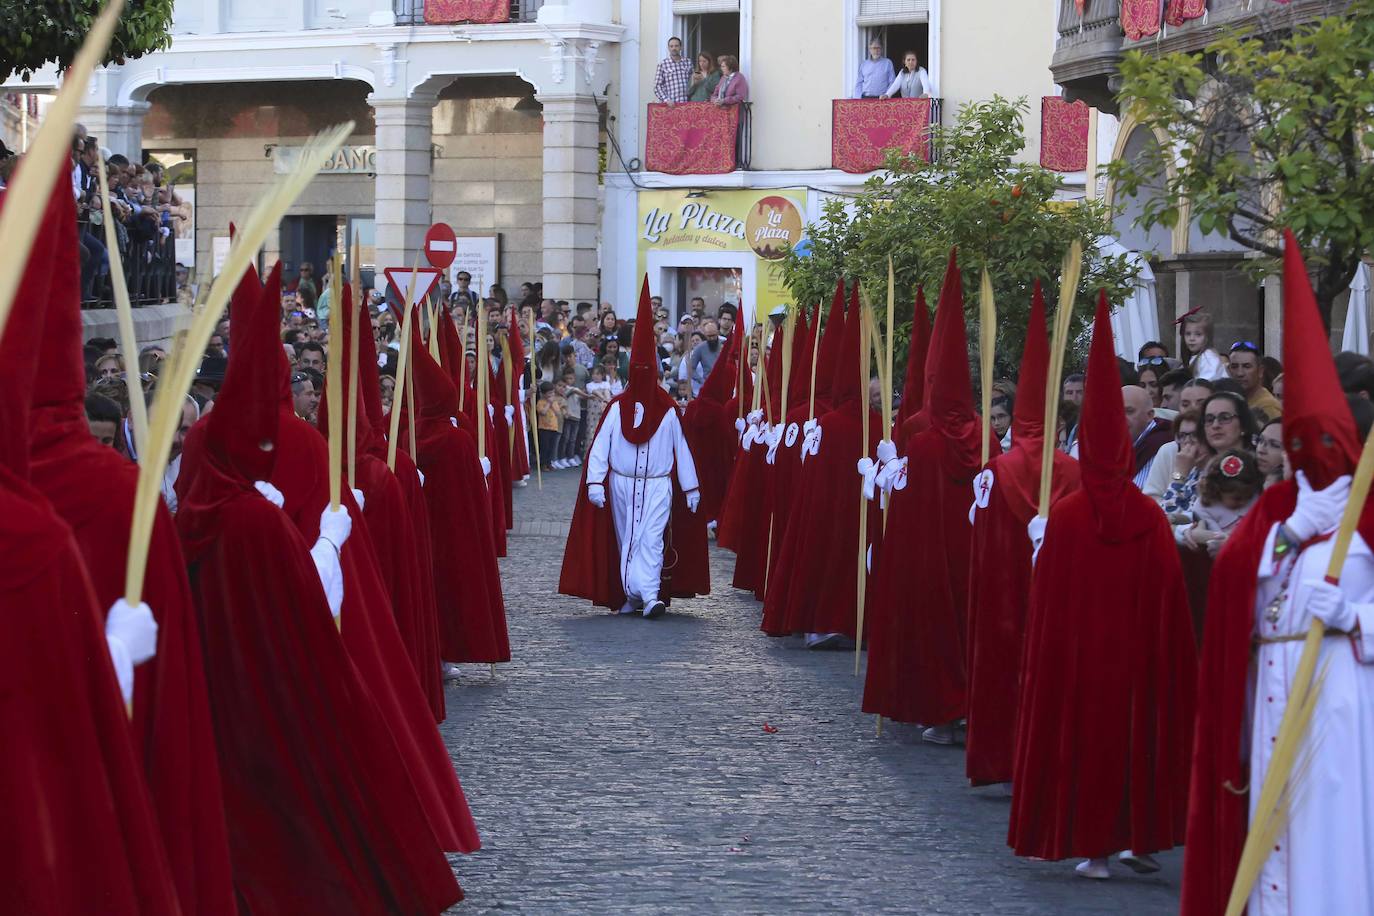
xmin=5 ymin=0 xmax=1066 ymax=312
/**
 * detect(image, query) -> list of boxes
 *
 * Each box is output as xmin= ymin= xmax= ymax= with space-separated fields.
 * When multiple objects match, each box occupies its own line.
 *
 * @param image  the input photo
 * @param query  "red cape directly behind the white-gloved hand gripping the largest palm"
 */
xmin=30 ymin=417 xmax=235 ymax=913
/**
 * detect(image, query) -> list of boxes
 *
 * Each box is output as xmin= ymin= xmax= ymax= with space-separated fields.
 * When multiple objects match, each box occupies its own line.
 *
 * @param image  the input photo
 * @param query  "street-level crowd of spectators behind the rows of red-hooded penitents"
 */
xmin=85 ymin=251 xmax=1374 ymax=645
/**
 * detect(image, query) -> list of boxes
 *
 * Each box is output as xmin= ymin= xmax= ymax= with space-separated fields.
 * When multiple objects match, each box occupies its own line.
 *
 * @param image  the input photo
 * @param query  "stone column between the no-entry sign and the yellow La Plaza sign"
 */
xmin=536 ymin=93 xmax=600 ymax=301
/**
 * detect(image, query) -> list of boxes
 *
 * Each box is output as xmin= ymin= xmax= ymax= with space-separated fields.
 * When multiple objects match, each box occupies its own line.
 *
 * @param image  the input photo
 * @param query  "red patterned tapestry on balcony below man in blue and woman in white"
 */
xmin=830 ymin=99 xmax=930 ymax=173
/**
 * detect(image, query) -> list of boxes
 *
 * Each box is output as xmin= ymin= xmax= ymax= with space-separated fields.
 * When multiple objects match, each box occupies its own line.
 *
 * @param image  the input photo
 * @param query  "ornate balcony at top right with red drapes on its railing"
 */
xmin=1050 ymin=0 xmax=1349 ymax=114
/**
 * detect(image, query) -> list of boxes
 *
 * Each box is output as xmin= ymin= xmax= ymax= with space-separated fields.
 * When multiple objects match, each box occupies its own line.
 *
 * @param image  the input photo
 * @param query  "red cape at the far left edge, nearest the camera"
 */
xmin=0 ymin=469 xmax=182 ymax=916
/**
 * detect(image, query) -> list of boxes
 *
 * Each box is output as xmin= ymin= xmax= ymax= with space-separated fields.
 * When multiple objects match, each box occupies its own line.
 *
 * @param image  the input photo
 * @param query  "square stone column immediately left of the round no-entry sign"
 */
xmin=368 ymin=93 xmax=436 ymax=273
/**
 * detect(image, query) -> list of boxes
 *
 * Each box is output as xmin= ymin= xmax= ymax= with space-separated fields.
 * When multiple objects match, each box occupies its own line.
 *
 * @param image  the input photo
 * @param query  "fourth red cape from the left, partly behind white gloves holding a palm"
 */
xmin=272 ymin=404 xmax=481 ymax=853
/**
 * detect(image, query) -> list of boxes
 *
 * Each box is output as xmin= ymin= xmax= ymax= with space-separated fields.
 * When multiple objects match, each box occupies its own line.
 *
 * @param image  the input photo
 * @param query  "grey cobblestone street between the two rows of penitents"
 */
xmin=442 ymin=470 xmax=1182 ymax=916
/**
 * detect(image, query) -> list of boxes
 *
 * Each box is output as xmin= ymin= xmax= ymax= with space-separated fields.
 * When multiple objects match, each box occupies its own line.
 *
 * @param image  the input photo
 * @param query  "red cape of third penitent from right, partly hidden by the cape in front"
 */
xmin=965 ymin=439 xmax=1079 ymax=786
